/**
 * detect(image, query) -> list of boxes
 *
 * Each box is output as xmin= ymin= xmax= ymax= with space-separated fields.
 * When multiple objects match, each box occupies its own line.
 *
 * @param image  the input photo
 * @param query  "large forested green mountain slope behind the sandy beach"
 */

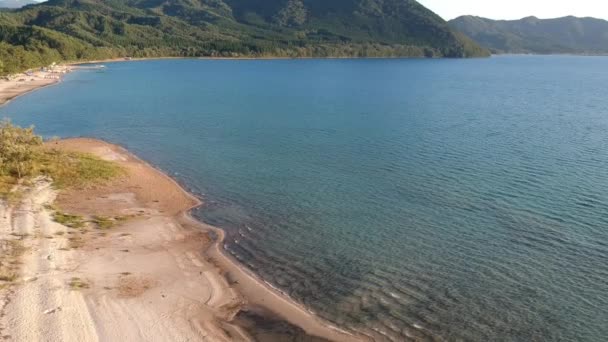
xmin=0 ymin=0 xmax=487 ymax=73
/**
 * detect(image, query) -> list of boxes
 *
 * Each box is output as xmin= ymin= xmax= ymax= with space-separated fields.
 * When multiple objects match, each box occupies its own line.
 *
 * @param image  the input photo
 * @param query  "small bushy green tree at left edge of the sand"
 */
xmin=0 ymin=120 xmax=42 ymax=179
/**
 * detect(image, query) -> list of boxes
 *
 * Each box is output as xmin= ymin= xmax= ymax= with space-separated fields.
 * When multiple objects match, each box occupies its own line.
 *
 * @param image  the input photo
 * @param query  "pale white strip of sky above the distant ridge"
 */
xmin=418 ymin=0 xmax=608 ymax=20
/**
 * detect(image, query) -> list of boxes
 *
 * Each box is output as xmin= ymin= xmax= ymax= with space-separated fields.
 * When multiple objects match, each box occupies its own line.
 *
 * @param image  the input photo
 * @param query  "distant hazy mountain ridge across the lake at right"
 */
xmin=449 ymin=16 xmax=608 ymax=54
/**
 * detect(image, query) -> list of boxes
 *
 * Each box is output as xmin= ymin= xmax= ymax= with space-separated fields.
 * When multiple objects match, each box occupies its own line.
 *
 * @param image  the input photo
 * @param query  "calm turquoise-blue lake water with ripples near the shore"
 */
xmin=0 ymin=56 xmax=608 ymax=341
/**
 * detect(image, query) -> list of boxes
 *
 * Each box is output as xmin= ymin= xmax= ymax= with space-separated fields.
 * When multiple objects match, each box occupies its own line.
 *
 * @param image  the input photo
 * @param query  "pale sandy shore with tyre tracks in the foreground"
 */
xmin=0 ymin=138 xmax=359 ymax=341
